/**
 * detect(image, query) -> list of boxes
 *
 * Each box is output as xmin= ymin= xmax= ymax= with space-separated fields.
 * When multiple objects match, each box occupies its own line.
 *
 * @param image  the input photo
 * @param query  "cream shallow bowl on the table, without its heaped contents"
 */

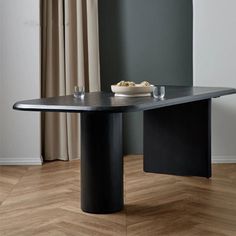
xmin=111 ymin=85 xmax=153 ymax=95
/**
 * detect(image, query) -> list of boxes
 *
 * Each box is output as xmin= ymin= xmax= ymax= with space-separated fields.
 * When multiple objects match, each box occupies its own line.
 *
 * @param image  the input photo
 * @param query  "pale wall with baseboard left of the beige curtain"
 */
xmin=0 ymin=0 xmax=41 ymax=164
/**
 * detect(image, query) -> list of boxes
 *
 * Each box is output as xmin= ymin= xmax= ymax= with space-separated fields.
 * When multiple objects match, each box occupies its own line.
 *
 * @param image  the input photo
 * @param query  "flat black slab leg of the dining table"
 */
xmin=144 ymin=99 xmax=211 ymax=178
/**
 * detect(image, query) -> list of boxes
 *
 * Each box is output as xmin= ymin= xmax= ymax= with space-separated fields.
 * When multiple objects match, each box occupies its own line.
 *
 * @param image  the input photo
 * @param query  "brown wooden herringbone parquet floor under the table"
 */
xmin=0 ymin=156 xmax=236 ymax=236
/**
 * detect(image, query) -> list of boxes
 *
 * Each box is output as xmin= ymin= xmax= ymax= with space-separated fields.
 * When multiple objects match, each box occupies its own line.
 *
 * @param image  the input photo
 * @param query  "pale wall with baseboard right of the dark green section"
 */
xmin=193 ymin=0 xmax=236 ymax=162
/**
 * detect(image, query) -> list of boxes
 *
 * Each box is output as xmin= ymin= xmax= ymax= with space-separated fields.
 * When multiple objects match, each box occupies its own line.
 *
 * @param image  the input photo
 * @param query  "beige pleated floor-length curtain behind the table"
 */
xmin=41 ymin=0 xmax=100 ymax=160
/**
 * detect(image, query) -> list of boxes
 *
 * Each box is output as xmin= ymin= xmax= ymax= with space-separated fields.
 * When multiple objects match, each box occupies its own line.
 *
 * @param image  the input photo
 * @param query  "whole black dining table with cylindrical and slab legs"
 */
xmin=13 ymin=86 xmax=236 ymax=213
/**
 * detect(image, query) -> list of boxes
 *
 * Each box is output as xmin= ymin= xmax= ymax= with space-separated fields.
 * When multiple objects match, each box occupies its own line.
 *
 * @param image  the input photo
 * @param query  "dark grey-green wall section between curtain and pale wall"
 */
xmin=98 ymin=0 xmax=193 ymax=154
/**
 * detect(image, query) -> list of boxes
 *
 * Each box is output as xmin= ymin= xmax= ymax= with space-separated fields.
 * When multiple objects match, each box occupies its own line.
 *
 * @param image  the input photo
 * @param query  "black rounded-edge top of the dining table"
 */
xmin=13 ymin=86 xmax=236 ymax=113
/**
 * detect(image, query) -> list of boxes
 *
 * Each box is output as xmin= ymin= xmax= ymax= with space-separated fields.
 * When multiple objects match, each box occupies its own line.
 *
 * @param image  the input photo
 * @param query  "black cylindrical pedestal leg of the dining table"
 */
xmin=81 ymin=113 xmax=124 ymax=213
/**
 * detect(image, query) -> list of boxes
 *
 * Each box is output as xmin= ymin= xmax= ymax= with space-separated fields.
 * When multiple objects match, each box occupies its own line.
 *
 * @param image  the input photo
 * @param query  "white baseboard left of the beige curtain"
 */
xmin=0 ymin=157 xmax=43 ymax=166
